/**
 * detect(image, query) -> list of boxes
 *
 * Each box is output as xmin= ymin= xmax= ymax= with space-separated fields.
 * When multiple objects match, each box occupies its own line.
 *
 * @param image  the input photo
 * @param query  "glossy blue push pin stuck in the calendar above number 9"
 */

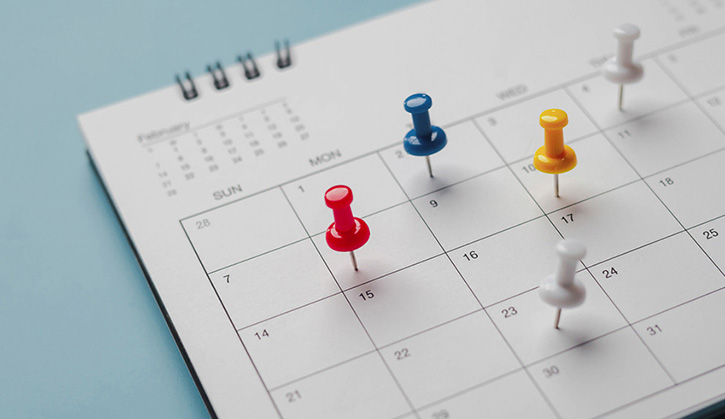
xmin=403 ymin=93 xmax=448 ymax=177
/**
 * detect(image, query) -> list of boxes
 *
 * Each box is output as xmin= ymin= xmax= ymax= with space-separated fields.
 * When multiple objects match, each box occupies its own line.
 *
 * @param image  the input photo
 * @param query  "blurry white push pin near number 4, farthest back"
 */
xmin=602 ymin=23 xmax=644 ymax=111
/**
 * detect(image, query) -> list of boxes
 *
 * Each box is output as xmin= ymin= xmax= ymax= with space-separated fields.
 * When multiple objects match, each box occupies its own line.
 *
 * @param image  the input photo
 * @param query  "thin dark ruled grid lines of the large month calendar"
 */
xmin=175 ymin=28 xmax=725 ymax=418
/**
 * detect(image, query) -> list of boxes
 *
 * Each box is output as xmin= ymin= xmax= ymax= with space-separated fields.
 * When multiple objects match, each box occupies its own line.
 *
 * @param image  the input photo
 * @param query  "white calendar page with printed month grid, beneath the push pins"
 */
xmin=80 ymin=0 xmax=725 ymax=419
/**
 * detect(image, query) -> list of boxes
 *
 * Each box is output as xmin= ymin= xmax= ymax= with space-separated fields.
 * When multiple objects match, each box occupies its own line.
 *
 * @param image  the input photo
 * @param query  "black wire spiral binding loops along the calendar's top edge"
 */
xmin=176 ymin=39 xmax=292 ymax=100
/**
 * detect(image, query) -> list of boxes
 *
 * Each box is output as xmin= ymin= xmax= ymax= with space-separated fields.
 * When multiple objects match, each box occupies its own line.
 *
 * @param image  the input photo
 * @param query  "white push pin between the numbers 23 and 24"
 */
xmin=539 ymin=239 xmax=587 ymax=329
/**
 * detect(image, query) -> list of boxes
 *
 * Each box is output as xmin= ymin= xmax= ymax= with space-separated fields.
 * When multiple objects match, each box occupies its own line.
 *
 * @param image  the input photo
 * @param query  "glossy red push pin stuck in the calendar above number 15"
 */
xmin=325 ymin=185 xmax=370 ymax=271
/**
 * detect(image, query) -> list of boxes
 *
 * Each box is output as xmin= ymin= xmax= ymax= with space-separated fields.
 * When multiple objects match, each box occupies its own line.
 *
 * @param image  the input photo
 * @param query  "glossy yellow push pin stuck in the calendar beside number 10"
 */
xmin=534 ymin=109 xmax=576 ymax=198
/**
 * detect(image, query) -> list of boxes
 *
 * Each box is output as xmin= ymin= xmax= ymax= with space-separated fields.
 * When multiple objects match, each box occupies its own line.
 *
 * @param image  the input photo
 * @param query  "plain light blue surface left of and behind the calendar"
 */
xmin=0 ymin=0 xmax=416 ymax=418
